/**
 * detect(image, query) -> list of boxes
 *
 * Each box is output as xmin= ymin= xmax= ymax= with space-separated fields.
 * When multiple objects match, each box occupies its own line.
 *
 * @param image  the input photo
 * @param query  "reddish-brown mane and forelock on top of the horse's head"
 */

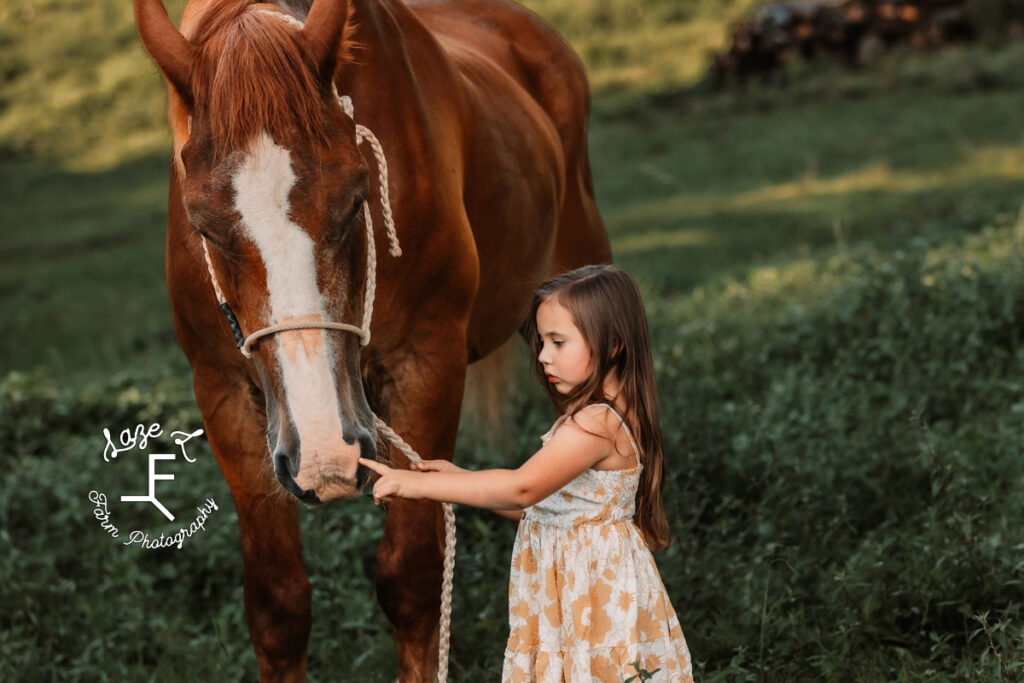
xmin=168 ymin=0 xmax=353 ymax=178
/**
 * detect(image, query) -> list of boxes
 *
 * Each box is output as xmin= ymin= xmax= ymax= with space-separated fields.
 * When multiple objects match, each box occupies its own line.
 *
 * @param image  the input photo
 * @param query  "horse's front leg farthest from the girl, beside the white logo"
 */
xmin=196 ymin=376 xmax=312 ymax=681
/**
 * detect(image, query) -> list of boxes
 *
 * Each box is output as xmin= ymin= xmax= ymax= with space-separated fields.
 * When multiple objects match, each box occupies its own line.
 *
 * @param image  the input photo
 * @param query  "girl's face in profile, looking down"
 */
xmin=537 ymin=298 xmax=594 ymax=393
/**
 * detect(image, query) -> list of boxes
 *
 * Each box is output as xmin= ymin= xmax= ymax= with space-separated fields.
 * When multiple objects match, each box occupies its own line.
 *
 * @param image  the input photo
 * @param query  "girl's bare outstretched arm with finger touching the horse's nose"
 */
xmin=359 ymin=414 xmax=611 ymax=512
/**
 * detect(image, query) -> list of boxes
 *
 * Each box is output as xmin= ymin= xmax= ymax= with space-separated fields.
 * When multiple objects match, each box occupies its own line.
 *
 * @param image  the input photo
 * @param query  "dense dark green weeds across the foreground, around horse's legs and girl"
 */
xmin=0 ymin=211 xmax=1024 ymax=681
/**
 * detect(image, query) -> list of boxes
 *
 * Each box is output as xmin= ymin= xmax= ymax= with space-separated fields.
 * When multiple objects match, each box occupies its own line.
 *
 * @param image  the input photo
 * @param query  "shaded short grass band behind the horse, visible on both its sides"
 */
xmin=8 ymin=69 xmax=1024 ymax=382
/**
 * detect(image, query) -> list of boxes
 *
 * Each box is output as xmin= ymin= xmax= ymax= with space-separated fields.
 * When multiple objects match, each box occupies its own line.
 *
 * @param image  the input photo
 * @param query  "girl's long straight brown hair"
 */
xmin=523 ymin=265 xmax=669 ymax=550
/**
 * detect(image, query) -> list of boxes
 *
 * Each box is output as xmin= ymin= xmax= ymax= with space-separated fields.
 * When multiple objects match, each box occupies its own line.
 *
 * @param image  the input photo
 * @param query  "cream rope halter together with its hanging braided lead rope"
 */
xmin=194 ymin=36 xmax=456 ymax=683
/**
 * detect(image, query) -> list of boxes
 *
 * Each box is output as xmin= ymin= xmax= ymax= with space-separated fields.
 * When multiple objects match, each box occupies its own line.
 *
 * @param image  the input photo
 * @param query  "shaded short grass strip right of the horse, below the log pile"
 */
xmin=594 ymin=83 xmax=1024 ymax=293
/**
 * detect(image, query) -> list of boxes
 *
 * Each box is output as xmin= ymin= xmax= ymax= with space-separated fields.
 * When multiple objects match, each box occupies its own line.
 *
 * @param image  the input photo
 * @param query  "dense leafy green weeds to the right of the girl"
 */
xmin=655 ymin=224 xmax=1024 ymax=680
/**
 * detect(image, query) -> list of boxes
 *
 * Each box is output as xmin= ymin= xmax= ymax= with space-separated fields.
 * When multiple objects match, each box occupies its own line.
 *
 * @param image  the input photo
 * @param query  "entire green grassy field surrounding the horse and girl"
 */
xmin=0 ymin=0 xmax=1024 ymax=682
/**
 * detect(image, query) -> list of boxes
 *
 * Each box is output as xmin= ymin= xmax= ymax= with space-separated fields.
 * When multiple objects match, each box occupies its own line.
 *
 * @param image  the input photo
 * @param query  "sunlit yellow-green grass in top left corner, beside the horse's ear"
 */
xmin=0 ymin=0 xmax=184 ymax=170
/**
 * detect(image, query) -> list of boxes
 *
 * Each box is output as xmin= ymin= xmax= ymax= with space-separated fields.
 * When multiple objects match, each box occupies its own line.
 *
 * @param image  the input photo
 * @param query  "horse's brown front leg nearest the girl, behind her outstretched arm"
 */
xmin=366 ymin=350 xmax=466 ymax=683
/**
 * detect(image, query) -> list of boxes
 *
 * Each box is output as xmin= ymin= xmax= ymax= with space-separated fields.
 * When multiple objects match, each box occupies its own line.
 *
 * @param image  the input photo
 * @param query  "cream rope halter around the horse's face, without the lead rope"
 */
xmin=195 ymin=89 xmax=401 ymax=358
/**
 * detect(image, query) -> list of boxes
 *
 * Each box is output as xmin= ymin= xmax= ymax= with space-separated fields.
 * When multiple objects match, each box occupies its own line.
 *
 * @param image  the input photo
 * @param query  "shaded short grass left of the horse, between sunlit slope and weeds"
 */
xmin=0 ymin=156 xmax=182 ymax=383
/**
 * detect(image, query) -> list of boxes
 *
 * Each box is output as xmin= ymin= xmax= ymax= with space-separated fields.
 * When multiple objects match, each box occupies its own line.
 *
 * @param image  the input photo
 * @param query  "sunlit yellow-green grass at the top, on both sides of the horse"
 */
xmin=0 ymin=0 xmax=752 ymax=170
